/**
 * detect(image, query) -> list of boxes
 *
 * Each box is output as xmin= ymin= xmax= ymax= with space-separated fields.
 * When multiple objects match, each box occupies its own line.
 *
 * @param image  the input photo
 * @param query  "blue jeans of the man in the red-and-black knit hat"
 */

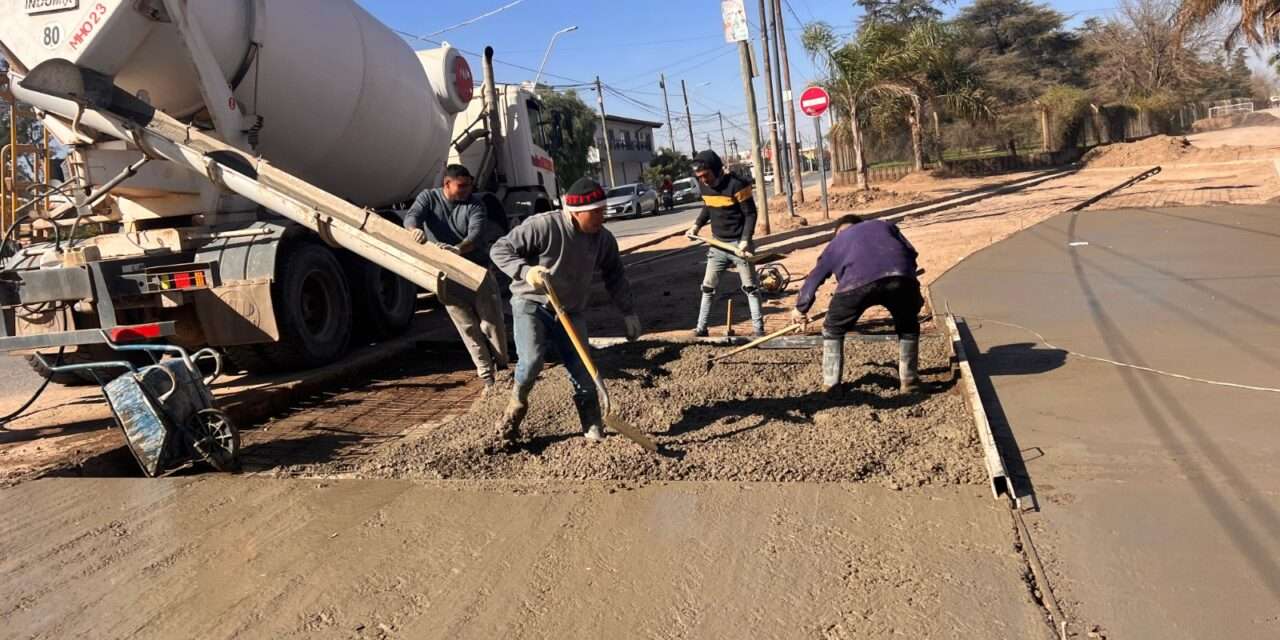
xmin=511 ymin=296 xmax=596 ymax=406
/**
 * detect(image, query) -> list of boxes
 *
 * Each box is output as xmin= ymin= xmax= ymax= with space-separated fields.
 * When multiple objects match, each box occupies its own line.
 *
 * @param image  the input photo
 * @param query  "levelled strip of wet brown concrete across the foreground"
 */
xmin=0 ymin=477 xmax=1052 ymax=640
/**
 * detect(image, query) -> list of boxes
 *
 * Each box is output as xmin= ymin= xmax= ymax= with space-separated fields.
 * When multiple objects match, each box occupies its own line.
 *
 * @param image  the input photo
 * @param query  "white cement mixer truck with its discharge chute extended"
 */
xmin=0 ymin=0 xmax=535 ymax=384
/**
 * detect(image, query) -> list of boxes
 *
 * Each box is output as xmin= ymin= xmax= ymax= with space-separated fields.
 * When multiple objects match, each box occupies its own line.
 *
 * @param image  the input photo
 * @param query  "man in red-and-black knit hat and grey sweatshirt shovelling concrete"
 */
xmin=489 ymin=178 xmax=641 ymax=447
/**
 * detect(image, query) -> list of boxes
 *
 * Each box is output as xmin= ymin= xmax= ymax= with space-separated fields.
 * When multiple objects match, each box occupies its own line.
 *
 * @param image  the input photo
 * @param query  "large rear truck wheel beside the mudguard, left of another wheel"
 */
xmin=257 ymin=242 xmax=351 ymax=370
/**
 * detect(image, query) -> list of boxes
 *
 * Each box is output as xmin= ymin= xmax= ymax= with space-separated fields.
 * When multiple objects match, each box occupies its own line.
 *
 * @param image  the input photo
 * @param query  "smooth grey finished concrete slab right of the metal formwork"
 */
xmin=933 ymin=206 xmax=1280 ymax=639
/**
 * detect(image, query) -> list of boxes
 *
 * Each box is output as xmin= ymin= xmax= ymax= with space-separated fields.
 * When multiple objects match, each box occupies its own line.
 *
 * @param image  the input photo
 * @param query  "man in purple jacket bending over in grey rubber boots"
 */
xmin=791 ymin=215 xmax=924 ymax=393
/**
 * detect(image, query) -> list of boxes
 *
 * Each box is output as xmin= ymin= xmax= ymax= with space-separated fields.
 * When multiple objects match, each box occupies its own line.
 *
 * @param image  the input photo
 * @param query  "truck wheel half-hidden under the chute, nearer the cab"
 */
xmin=346 ymin=256 xmax=417 ymax=340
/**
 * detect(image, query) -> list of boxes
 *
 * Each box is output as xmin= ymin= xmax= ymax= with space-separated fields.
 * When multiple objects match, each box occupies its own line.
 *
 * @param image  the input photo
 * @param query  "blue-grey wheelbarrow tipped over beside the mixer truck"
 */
xmin=36 ymin=333 xmax=239 ymax=477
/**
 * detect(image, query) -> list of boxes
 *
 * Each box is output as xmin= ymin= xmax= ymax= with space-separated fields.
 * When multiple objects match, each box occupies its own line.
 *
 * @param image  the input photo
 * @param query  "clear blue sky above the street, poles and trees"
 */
xmin=357 ymin=0 xmax=1274 ymax=148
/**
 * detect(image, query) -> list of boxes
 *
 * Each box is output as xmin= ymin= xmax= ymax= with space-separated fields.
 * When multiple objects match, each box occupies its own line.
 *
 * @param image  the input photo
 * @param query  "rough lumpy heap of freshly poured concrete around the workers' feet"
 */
xmin=358 ymin=337 xmax=986 ymax=486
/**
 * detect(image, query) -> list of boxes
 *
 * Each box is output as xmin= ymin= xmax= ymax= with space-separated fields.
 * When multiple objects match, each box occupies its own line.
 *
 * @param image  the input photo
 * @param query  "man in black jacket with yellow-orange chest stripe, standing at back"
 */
xmin=687 ymin=150 xmax=764 ymax=338
